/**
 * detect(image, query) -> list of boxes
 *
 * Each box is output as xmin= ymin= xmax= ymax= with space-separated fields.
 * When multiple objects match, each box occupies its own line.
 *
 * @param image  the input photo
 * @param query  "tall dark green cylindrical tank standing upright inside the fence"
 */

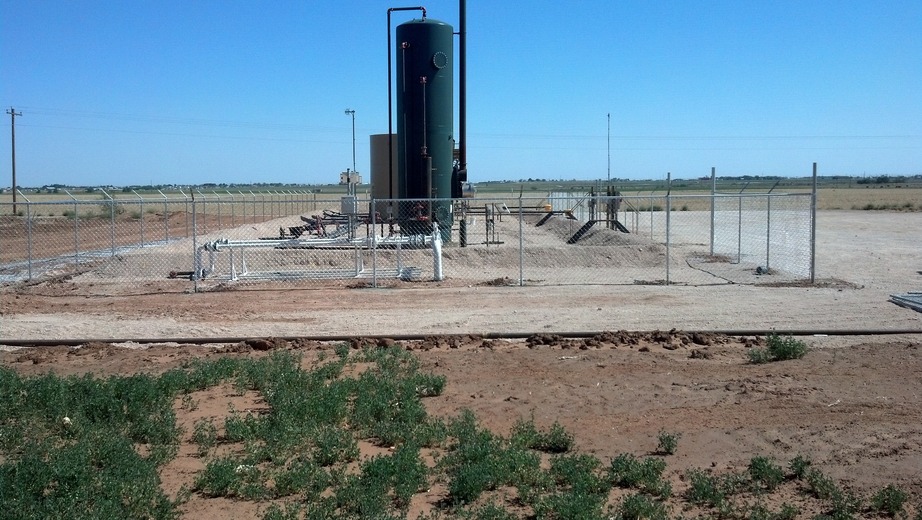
xmin=394 ymin=18 xmax=455 ymax=241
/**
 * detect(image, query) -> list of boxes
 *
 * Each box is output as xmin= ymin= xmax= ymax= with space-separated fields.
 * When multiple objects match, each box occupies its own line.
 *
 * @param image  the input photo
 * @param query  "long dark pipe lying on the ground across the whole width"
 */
xmin=0 ymin=329 xmax=922 ymax=347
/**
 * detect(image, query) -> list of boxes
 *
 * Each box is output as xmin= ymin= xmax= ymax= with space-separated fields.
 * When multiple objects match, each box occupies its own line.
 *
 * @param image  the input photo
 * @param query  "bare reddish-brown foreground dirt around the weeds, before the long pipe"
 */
xmin=0 ymin=332 xmax=922 ymax=519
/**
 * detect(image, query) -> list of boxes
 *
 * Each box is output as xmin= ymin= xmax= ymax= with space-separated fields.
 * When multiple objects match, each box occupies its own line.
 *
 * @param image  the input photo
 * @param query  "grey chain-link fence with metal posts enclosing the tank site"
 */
xmin=0 ymin=191 xmax=814 ymax=291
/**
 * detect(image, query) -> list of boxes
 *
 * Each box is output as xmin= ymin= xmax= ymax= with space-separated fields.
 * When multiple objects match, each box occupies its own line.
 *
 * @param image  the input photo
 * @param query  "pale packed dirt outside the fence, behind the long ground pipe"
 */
xmin=0 ymin=211 xmax=922 ymax=338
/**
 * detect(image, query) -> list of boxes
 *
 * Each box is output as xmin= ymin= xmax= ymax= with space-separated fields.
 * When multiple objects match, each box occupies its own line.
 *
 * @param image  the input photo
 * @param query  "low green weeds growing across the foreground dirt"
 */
xmin=0 ymin=346 xmax=919 ymax=520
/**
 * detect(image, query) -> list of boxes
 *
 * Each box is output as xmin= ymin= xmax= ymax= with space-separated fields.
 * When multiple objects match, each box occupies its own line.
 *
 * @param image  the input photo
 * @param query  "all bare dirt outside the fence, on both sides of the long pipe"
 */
xmin=0 ymin=211 xmax=922 ymax=518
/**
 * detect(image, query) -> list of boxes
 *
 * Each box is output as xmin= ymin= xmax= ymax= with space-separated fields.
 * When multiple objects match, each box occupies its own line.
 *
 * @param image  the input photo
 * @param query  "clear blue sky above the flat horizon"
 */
xmin=0 ymin=0 xmax=922 ymax=186
